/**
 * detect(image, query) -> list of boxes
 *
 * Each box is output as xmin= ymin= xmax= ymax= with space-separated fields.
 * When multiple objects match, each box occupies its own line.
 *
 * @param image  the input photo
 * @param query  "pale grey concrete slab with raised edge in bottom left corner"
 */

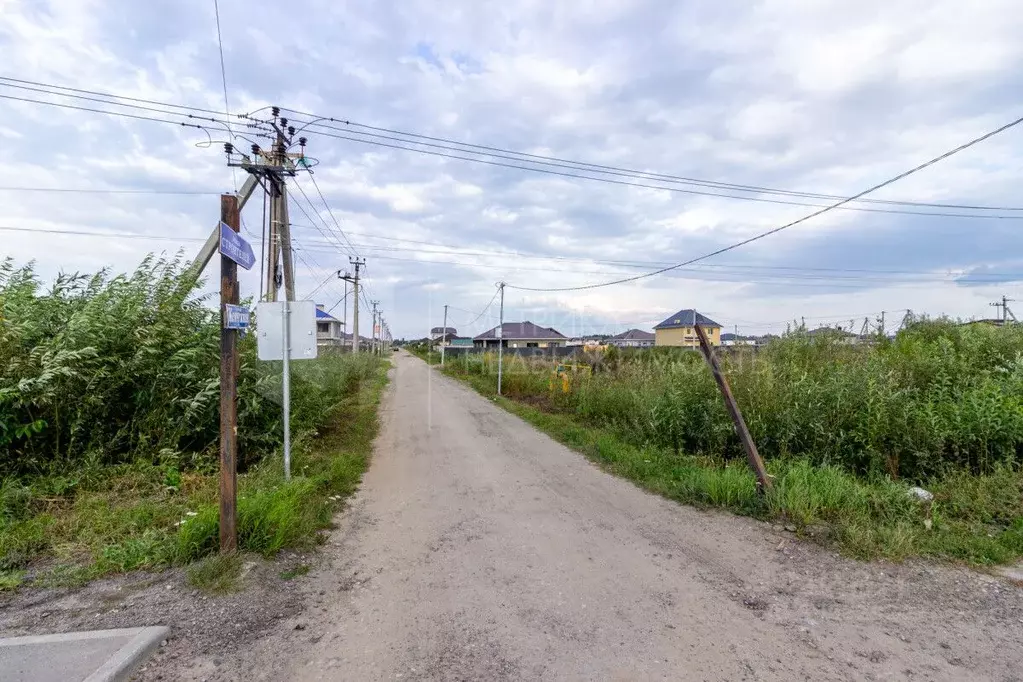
xmin=0 ymin=627 xmax=171 ymax=682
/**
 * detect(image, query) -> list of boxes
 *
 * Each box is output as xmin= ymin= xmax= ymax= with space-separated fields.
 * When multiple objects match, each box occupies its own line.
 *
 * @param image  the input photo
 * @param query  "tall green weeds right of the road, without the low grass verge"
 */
xmin=449 ymin=320 xmax=1023 ymax=481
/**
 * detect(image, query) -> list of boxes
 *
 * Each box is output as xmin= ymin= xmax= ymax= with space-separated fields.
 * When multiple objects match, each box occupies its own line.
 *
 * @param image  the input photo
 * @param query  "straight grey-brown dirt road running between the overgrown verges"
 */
xmin=180 ymin=354 xmax=1023 ymax=681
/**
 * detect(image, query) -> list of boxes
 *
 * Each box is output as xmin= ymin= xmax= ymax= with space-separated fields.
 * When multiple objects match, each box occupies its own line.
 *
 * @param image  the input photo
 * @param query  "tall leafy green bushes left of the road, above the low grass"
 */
xmin=0 ymin=257 xmax=372 ymax=480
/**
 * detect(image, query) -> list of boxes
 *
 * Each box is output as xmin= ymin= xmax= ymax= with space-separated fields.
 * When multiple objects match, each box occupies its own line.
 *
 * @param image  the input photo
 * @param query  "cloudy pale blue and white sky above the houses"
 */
xmin=0 ymin=0 xmax=1023 ymax=337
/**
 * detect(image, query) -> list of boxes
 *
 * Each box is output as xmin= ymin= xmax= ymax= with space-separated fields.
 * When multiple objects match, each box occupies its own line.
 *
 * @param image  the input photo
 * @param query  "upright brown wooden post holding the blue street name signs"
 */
xmin=220 ymin=194 xmax=241 ymax=554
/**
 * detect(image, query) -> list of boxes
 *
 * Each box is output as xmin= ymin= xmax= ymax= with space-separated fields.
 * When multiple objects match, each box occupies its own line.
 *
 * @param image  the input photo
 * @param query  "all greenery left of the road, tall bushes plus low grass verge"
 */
xmin=0 ymin=262 xmax=388 ymax=589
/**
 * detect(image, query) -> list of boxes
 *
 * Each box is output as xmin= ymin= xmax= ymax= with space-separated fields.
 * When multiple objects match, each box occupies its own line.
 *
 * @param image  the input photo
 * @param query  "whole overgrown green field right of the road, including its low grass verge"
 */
xmin=445 ymin=322 xmax=1023 ymax=564
